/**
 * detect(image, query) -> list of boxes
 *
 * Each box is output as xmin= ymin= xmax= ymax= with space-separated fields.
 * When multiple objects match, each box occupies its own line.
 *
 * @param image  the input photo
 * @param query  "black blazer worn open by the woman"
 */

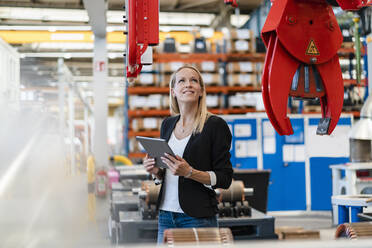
xmin=157 ymin=115 xmax=233 ymax=217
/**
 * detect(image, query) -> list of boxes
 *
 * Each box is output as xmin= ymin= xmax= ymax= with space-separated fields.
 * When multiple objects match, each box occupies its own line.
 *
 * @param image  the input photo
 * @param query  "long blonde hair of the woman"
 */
xmin=169 ymin=65 xmax=212 ymax=133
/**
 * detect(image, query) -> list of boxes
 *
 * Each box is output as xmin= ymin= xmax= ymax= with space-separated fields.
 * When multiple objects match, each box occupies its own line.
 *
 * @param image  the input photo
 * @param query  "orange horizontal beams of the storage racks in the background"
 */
xmin=128 ymin=45 xmax=365 ymax=158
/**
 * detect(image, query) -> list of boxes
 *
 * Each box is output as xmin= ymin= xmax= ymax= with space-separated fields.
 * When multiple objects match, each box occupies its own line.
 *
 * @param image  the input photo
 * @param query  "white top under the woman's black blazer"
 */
xmin=159 ymin=132 xmax=191 ymax=213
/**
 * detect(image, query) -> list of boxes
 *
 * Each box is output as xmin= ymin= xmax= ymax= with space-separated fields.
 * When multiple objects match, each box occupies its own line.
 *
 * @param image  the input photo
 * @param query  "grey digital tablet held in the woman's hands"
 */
xmin=136 ymin=136 xmax=176 ymax=168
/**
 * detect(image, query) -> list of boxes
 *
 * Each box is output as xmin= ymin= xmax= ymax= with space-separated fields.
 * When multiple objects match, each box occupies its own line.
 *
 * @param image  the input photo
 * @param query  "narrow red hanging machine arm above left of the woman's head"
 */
xmin=124 ymin=0 xmax=159 ymax=80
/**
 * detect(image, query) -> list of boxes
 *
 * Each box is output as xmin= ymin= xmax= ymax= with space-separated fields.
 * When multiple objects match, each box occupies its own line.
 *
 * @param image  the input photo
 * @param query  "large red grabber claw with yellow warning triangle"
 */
xmin=261 ymin=0 xmax=371 ymax=135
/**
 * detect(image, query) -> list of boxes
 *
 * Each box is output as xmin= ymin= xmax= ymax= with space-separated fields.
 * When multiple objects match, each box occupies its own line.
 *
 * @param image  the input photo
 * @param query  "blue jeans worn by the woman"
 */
xmin=158 ymin=210 xmax=218 ymax=244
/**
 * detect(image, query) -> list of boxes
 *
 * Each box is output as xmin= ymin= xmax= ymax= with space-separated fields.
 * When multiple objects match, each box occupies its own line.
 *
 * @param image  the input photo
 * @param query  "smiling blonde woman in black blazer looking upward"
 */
xmin=144 ymin=66 xmax=233 ymax=243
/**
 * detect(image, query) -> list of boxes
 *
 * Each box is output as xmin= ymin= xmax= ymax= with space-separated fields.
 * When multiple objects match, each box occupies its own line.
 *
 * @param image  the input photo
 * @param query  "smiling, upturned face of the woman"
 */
xmin=172 ymin=68 xmax=203 ymax=103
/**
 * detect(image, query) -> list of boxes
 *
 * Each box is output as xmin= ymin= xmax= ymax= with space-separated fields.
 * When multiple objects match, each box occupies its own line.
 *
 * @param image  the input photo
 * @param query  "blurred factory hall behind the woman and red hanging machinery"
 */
xmin=0 ymin=0 xmax=372 ymax=247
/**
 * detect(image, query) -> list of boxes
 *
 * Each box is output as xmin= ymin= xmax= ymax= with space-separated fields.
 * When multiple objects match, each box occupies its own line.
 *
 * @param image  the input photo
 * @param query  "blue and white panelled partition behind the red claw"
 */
xmin=225 ymin=114 xmax=353 ymax=211
